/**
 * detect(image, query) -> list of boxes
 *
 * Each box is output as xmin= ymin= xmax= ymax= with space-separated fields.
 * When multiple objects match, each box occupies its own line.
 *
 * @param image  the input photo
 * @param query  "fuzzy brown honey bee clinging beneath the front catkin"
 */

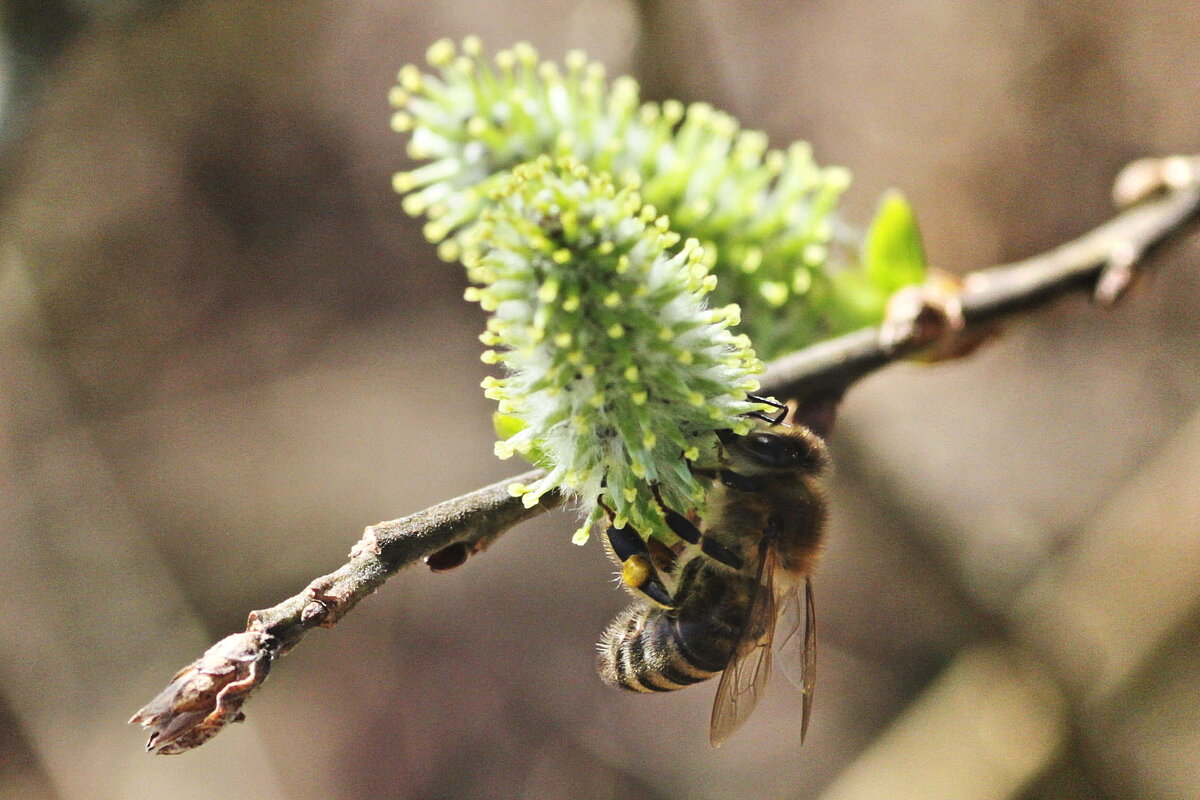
xmin=598 ymin=419 xmax=828 ymax=747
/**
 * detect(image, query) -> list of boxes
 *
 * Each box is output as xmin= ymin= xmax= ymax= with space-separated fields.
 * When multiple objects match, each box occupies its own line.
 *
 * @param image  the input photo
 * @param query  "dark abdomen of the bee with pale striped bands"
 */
xmin=599 ymin=555 xmax=754 ymax=692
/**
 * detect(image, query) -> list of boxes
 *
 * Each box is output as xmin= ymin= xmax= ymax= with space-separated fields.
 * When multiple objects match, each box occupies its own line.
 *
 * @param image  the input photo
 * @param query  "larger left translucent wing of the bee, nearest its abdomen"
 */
xmin=708 ymin=548 xmax=776 ymax=747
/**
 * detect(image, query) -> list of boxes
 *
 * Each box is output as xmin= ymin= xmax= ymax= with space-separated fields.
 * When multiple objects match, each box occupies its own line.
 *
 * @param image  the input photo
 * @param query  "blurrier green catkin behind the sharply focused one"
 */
xmin=391 ymin=37 xmax=897 ymax=357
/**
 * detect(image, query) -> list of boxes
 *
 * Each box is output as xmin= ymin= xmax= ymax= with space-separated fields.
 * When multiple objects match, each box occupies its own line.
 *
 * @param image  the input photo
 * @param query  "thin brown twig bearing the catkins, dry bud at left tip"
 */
xmin=131 ymin=157 xmax=1200 ymax=754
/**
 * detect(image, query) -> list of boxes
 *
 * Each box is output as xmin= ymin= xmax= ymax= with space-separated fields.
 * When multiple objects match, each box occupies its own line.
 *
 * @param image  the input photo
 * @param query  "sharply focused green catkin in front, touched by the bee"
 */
xmin=462 ymin=157 xmax=762 ymax=539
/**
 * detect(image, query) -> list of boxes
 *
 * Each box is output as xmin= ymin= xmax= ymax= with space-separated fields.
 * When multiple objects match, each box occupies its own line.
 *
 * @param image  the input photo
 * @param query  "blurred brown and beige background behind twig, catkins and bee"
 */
xmin=0 ymin=0 xmax=1200 ymax=800
